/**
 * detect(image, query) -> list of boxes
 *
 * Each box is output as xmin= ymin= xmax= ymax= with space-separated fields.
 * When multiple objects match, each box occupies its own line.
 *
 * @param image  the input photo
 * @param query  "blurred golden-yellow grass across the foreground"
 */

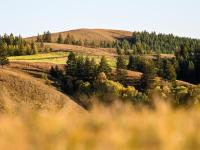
xmin=0 ymin=99 xmax=200 ymax=150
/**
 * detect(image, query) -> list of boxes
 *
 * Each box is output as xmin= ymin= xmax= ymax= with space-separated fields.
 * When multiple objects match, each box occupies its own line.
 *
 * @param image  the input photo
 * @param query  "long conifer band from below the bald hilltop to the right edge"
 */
xmin=37 ymin=31 xmax=200 ymax=55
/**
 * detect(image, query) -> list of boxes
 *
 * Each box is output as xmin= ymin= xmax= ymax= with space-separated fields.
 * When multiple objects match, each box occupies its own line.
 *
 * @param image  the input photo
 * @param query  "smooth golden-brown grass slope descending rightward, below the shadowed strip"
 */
xmin=0 ymin=65 xmax=81 ymax=110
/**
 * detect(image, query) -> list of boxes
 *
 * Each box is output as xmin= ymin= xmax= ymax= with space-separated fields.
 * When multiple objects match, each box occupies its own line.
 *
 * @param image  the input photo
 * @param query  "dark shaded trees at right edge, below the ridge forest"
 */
xmin=128 ymin=44 xmax=200 ymax=84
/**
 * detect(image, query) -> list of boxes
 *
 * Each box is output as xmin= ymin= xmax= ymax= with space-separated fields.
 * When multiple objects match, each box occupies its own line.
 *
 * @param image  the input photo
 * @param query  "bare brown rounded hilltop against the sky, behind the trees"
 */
xmin=27 ymin=29 xmax=132 ymax=42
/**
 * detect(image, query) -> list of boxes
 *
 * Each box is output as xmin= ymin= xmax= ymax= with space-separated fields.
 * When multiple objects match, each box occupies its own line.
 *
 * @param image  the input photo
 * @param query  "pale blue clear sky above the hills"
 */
xmin=0 ymin=0 xmax=200 ymax=38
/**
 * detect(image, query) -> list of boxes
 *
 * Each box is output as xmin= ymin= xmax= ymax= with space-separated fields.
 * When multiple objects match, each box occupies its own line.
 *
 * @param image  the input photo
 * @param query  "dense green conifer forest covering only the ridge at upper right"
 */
xmin=131 ymin=31 xmax=200 ymax=54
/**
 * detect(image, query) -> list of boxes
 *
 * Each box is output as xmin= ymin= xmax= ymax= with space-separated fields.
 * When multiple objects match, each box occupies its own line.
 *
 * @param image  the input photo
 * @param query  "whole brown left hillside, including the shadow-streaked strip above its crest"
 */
xmin=0 ymin=62 xmax=81 ymax=109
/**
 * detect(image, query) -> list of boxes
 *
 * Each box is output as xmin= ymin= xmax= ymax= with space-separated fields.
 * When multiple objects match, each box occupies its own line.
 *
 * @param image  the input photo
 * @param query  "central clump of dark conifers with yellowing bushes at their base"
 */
xmin=50 ymin=53 xmax=148 ymax=106
